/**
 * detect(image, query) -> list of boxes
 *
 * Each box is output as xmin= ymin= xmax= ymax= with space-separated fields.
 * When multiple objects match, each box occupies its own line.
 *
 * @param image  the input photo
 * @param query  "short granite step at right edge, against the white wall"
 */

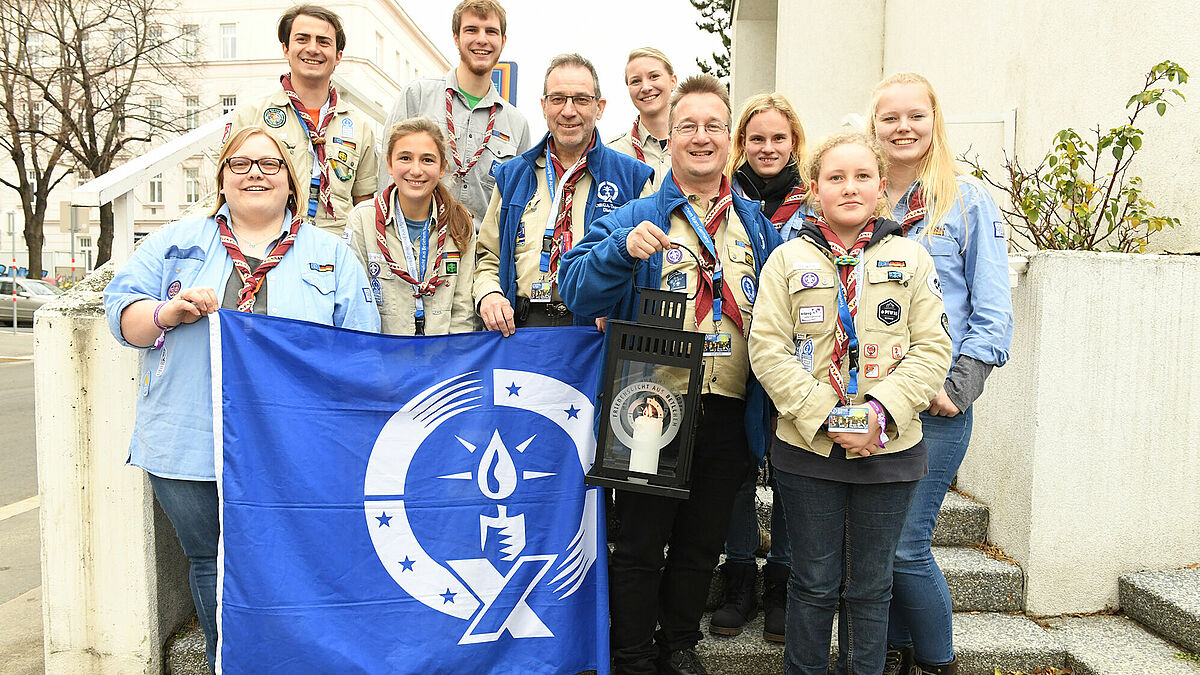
xmin=1117 ymin=568 xmax=1200 ymax=652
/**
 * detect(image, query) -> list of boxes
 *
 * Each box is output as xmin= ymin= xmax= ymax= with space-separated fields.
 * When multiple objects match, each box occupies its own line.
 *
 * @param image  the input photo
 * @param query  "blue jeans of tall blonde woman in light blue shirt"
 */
xmin=888 ymin=408 xmax=971 ymax=664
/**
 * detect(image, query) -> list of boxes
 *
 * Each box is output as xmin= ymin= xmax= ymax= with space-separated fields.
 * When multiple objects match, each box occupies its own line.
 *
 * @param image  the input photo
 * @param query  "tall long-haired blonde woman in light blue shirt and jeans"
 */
xmin=868 ymin=73 xmax=1013 ymax=675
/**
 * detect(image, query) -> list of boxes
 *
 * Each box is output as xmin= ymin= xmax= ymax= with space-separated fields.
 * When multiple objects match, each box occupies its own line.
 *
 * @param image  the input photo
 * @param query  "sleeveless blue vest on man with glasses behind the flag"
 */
xmin=496 ymin=133 xmax=654 ymax=325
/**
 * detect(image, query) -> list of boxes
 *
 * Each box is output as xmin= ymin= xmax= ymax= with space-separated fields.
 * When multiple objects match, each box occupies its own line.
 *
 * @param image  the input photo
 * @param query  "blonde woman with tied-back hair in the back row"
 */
xmin=608 ymin=47 xmax=679 ymax=184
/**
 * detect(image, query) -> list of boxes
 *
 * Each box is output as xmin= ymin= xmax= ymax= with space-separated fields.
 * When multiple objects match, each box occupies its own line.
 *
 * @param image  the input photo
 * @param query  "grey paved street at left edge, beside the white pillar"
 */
xmin=0 ymin=325 xmax=43 ymax=675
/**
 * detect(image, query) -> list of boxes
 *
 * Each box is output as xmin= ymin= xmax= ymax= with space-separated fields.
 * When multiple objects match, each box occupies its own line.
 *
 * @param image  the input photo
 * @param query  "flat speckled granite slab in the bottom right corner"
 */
xmin=1049 ymin=616 xmax=1200 ymax=675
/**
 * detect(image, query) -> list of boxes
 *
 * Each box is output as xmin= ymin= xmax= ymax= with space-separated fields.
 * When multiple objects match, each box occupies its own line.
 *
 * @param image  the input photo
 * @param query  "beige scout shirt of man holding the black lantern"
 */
xmin=662 ymin=196 xmax=757 ymax=399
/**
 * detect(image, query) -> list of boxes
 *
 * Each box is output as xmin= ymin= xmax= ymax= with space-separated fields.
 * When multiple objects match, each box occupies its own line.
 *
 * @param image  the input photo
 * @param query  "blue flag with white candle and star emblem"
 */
xmin=212 ymin=311 xmax=608 ymax=674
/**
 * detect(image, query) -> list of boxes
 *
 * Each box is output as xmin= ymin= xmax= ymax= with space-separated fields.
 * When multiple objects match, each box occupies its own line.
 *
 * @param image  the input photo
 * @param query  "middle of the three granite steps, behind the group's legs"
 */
xmin=706 ymin=546 xmax=1025 ymax=611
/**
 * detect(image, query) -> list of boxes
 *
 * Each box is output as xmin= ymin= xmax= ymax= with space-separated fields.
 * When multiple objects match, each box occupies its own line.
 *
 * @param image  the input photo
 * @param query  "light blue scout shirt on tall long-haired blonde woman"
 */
xmin=892 ymin=175 xmax=1013 ymax=366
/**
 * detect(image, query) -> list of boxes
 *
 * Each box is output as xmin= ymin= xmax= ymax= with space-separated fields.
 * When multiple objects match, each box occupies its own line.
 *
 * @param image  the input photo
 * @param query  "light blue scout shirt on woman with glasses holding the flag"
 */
xmin=104 ymin=207 xmax=379 ymax=480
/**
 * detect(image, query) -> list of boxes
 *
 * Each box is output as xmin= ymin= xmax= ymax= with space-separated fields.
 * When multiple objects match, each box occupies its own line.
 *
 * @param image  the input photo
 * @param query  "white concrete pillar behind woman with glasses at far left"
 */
xmin=34 ymin=265 xmax=193 ymax=675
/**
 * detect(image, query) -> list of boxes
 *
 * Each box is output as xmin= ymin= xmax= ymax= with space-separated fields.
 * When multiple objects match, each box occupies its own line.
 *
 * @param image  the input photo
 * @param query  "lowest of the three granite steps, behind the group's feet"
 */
xmin=696 ymin=614 xmax=1066 ymax=675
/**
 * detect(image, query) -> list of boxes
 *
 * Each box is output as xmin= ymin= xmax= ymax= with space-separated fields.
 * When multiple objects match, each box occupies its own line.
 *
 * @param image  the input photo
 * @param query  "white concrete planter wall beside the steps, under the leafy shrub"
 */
xmin=959 ymin=252 xmax=1200 ymax=615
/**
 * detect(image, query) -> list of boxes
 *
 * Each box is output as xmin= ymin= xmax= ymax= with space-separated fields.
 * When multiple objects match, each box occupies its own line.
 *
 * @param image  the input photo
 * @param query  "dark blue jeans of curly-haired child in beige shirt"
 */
xmin=775 ymin=471 xmax=917 ymax=675
